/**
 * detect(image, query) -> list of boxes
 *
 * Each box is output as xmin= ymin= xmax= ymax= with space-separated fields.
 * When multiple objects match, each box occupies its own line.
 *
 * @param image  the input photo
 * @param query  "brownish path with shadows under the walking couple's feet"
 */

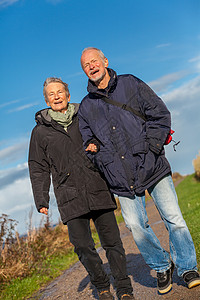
xmin=29 ymin=200 xmax=200 ymax=300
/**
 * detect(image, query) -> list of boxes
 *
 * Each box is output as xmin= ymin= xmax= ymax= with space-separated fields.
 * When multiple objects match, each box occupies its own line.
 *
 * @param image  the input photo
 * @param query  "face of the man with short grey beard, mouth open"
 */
xmin=81 ymin=49 xmax=108 ymax=82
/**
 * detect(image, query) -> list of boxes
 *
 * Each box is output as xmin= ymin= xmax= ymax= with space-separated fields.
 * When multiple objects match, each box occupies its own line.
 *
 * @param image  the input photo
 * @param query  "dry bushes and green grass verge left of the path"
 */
xmin=0 ymin=202 xmax=122 ymax=300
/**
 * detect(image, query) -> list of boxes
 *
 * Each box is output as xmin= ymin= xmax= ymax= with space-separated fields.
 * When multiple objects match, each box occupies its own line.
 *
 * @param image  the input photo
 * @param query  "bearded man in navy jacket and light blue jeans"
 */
xmin=79 ymin=47 xmax=200 ymax=294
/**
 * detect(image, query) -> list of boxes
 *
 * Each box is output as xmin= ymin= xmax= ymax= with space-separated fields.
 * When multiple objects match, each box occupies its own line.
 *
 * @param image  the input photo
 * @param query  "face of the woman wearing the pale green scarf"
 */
xmin=46 ymin=82 xmax=70 ymax=113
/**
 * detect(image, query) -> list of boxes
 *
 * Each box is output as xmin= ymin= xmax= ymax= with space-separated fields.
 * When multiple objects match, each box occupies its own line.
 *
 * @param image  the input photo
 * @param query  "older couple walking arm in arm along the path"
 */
xmin=29 ymin=48 xmax=200 ymax=300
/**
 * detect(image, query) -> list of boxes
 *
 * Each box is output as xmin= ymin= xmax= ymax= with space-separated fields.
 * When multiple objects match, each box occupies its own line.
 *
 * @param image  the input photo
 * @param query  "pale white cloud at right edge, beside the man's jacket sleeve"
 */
xmin=155 ymin=72 xmax=200 ymax=175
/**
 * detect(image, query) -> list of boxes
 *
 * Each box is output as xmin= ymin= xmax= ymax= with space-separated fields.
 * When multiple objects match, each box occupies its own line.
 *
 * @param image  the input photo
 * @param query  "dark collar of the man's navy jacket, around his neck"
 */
xmin=87 ymin=68 xmax=117 ymax=96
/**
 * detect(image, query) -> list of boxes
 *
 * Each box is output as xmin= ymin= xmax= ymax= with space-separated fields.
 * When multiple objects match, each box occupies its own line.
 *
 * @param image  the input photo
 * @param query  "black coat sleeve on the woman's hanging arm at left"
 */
xmin=28 ymin=126 xmax=51 ymax=211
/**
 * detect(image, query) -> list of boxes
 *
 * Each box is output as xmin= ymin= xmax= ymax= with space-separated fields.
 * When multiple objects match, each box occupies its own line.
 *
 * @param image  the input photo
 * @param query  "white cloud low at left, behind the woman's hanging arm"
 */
xmin=0 ymin=169 xmax=59 ymax=234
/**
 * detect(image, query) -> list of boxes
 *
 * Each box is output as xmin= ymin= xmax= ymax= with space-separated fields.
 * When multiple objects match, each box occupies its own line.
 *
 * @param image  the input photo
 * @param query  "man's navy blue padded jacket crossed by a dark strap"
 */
xmin=78 ymin=69 xmax=171 ymax=196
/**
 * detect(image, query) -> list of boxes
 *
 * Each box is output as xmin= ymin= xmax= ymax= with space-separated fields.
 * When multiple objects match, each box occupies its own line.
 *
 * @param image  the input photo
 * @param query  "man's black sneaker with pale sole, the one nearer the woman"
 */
xmin=157 ymin=261 xmax=174 ymax=294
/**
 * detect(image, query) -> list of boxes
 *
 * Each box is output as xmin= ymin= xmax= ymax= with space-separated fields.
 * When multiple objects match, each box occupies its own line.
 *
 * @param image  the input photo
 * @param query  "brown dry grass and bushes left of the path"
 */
xmin=0 ymin=214 xmax=72 ymax=284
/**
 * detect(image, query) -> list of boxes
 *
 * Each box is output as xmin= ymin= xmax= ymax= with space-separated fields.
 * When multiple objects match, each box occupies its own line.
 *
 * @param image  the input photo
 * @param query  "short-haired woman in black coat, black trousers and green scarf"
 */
xmin=29 ymin=77 xmax=134 ymax=300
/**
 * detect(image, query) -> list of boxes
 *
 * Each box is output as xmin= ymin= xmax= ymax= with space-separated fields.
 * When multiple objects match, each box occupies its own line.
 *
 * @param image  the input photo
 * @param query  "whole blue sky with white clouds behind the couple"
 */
xmin=0 ymin=0 xmax=200 ymax=233
